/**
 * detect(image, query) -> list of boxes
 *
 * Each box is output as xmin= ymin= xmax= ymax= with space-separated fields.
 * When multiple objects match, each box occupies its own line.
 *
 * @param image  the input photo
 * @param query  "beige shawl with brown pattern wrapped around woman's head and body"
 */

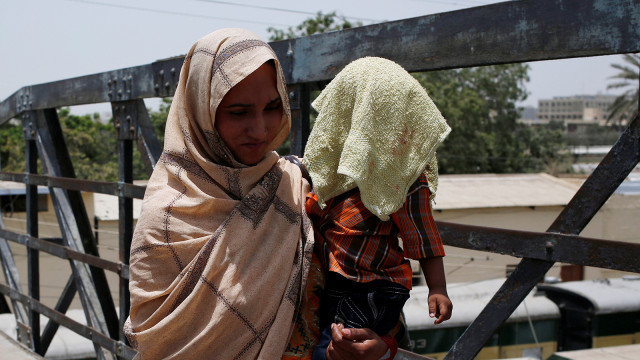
xmin=125 ymin=29 xmax=313 ymax=360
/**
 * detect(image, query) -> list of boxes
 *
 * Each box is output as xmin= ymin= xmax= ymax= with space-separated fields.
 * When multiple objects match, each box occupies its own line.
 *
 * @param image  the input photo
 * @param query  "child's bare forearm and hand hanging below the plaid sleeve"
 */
xmin=419 ymin=256 xmax=453 ymax=324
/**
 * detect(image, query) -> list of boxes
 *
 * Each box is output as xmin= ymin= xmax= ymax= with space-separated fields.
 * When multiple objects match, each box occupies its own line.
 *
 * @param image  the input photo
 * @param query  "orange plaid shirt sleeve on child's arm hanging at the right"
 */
xmin=391 ymin=174 xmax=444 ymax=260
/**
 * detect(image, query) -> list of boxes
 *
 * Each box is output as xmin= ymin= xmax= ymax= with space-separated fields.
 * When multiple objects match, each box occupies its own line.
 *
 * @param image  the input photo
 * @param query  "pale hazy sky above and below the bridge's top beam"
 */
xmin=0 ymin=0 xmax=623 ymax=114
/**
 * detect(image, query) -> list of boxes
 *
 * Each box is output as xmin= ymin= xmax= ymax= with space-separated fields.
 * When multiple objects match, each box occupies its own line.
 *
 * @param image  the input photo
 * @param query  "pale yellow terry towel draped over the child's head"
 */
xmin=304 ymin=57 xmax=451 ymax=221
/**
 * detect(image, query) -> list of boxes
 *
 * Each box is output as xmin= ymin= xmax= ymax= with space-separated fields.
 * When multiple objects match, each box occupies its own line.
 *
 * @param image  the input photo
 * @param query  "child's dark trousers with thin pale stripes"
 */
xmin=312 ymin=272 xmax=409 ymax=360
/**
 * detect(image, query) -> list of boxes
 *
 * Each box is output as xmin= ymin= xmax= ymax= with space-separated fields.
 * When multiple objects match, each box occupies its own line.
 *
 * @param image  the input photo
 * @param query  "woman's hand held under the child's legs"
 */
xmin=327 ymin=324 xmax=388 ymax=360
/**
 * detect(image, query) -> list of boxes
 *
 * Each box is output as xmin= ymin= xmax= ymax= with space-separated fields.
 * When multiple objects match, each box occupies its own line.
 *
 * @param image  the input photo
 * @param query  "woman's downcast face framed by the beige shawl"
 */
xmin=215 ymin=63 xmax=282 ymax=165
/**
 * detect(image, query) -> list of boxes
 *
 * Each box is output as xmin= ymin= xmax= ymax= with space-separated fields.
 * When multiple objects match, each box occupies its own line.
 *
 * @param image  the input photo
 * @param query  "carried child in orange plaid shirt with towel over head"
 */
xmin=304 ymin=57 xmax=452 ymax=359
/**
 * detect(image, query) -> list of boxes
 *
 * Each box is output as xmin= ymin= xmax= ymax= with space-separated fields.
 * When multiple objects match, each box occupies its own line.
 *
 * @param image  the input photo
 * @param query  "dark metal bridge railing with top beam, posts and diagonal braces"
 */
xmin=0 ymin=0 xmax=640 ymax=359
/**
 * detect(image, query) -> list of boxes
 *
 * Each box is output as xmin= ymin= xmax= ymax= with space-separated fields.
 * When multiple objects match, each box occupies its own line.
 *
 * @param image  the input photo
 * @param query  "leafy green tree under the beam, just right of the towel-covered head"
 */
xmin=414 ymin=64 xmax=558 ymax=173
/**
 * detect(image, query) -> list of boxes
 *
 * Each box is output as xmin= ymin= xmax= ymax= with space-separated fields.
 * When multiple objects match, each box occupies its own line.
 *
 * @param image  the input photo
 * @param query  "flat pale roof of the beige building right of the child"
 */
xmin=434 ymin=173 xmax=580 ymax=210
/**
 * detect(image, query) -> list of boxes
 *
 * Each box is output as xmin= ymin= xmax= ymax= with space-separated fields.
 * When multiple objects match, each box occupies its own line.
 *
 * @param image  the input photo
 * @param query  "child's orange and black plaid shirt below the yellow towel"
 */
xmin=306 ymin=174 xmax=444 ymax=289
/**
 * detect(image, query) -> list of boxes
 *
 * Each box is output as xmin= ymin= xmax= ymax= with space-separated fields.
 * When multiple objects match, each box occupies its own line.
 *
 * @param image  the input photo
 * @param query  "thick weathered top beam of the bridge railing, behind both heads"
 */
xmin=0 ymin=0 xmax=640 ymax=125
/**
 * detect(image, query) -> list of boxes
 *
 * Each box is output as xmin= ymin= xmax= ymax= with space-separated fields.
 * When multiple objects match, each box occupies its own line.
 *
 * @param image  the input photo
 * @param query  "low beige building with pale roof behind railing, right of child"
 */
xmin=434 ymin=173 xmax=640 ymax=282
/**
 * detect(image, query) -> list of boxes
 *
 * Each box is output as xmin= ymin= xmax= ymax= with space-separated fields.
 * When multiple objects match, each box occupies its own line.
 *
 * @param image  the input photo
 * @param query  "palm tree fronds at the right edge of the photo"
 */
xmin=607 ymin=54 xmax=640 ymax=125
